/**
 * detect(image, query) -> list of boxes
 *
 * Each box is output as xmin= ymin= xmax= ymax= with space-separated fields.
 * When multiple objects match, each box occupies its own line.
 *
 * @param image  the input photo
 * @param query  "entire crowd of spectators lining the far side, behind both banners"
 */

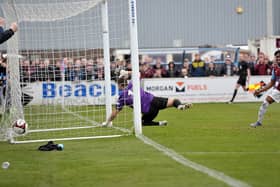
xmin=0 ymin=52 xmax=274 ymax=82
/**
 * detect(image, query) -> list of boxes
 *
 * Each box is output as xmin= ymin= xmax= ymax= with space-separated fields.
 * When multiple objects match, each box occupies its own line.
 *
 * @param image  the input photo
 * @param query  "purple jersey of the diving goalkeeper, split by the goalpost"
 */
xmin=116 ymin=81 xmax=154 ymax=113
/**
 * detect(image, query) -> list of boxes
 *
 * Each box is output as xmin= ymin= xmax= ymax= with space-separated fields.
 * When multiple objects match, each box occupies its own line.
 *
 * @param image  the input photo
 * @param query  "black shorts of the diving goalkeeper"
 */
xmin=142 ymin=97 xmax=168 ymax=122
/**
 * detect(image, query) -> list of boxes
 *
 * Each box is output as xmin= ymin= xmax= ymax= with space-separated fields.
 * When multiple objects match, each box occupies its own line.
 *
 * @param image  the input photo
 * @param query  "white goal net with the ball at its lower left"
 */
xmin=0 ymin=0 xmax=139 ymax=143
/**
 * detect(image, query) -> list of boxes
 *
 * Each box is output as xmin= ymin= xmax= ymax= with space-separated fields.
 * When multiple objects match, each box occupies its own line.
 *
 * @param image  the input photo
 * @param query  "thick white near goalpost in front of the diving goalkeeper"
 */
xmin=128 ymin=0 xmax=142 ymax=135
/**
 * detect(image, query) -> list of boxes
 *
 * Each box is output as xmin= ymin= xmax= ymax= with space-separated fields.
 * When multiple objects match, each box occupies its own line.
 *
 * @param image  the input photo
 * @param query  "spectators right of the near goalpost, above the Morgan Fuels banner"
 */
xmin=140 ymin=52 xmax=274 ymax=78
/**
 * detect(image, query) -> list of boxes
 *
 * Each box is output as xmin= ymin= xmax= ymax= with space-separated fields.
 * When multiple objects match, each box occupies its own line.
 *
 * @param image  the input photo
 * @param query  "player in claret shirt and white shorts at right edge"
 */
xmin=250 ymin=50 xmax=280 ymax=127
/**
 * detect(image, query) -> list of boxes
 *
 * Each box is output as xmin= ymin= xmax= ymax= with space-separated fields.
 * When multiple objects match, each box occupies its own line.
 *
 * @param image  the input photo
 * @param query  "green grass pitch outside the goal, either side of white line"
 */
xmin=0 ymin=103 xmax=280 ymax=187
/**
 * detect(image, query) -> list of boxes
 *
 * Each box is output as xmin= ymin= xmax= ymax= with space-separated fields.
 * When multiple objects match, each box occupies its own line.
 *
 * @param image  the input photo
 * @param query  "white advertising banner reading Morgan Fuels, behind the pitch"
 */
xmin=143 ymin=76 xmax=270 ymax=103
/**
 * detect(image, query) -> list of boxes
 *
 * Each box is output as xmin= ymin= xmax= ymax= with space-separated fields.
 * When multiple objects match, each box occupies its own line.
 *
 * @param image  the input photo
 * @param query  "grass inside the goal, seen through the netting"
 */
xmin=9 ymin=105 xmax=133 ymax=143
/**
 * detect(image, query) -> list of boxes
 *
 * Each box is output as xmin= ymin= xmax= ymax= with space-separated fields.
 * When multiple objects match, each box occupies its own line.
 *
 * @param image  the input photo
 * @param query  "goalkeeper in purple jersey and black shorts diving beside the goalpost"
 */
xmin=102 ymin=70 xmax=192 ymax=126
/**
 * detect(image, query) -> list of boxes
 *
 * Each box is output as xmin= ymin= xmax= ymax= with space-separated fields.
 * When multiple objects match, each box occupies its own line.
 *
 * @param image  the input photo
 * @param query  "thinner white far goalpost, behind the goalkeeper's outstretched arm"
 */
xmin=101 ymin=0 xmax=112 ymax=119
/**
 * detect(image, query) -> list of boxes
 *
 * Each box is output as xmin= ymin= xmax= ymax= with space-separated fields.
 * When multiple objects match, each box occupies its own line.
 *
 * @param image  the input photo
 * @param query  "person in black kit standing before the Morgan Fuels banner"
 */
xmin=228 ymin=55 xmax=251 ymax=104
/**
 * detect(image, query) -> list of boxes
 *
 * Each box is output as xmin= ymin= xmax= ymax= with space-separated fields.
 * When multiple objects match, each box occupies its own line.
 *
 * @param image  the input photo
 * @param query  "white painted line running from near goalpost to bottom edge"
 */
xmin=136 ymin=135 xmax=250 ymax=187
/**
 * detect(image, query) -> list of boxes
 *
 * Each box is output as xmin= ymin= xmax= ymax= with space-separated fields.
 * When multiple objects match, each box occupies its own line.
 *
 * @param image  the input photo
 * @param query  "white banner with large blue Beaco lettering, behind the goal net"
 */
xmin=22 ymin=81 xmax=118 ymax=105
